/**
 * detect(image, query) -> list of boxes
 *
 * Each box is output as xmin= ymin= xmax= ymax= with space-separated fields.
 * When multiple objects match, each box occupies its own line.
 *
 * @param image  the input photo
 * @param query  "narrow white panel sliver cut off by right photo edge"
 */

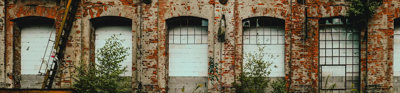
xmin=393 ymin=24 xmax=400 ymax=76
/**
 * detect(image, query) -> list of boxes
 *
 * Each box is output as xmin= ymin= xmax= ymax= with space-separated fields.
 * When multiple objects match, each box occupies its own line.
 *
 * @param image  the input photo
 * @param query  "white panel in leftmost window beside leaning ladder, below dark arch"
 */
xmin=21 ymin=24 xmax=55 ymax=74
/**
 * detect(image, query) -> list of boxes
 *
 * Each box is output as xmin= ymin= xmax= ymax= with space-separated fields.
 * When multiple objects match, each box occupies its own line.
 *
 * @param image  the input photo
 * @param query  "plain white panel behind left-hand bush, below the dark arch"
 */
xmin=95 ymin=26 xmax=132 ymax=76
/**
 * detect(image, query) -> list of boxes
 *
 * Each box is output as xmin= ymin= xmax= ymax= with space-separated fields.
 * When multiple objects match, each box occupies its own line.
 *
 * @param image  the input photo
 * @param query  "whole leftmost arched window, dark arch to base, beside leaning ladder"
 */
xmin=14 ymin=16 xmax=56 ymax=88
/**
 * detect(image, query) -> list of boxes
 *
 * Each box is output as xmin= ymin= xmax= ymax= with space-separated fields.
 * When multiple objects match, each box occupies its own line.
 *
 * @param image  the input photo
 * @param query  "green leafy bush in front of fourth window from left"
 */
xmin=233 ymin=47 xmax=272 ymax=93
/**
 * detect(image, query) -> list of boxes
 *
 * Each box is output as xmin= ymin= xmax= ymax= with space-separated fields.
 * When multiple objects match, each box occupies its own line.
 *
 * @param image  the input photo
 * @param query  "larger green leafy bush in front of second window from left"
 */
xmin=73 ymin=35 xmax=130 ymax=93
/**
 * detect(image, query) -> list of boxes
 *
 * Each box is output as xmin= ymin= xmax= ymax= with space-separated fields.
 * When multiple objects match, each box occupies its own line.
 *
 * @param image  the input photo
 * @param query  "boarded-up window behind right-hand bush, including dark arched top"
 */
xmin=243 ymin=17 xmax=285 ymax=77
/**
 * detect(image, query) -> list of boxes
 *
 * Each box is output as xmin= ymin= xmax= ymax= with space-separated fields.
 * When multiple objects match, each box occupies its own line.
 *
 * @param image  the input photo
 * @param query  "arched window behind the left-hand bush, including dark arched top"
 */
xmin=91 ymin=16 xmax=133 ymax=76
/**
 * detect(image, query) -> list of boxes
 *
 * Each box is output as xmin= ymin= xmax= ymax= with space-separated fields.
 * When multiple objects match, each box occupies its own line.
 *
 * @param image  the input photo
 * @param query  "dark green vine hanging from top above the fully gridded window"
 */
xmin=347 ymin=0 xmax=382 ymax=29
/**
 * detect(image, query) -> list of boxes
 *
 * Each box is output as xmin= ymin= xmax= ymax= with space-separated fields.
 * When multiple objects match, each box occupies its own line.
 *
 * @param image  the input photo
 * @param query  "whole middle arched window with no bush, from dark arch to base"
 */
xmin=167 ymin=17 xmax=208 ymax=93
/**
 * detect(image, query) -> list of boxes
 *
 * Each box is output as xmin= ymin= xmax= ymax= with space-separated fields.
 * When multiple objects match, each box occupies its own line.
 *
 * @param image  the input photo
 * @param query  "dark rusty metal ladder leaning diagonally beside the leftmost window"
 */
xmin=42 ymin=0 xmax=80 ymax=89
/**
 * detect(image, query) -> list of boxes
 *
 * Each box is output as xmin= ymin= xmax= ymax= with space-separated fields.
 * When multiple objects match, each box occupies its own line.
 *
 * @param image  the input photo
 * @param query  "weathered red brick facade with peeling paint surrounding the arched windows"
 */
xmin=0 ymin=0 xmax=400 ymax=92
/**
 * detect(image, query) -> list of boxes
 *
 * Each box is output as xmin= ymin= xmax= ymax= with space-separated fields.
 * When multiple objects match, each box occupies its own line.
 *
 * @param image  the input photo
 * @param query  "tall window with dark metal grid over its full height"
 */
xmin=319 ymin=17 xmax=360 ymax=92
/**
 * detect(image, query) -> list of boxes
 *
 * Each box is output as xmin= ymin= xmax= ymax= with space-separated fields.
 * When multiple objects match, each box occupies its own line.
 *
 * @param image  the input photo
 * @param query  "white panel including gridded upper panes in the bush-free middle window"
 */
xmin=168 ymin=26 xmax=208 ymax=76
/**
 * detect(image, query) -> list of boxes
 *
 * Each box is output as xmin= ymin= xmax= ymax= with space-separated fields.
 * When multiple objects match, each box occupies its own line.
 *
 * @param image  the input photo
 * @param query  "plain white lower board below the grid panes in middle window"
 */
xmin=169 ymin=44 xmax=208 ymax=76
